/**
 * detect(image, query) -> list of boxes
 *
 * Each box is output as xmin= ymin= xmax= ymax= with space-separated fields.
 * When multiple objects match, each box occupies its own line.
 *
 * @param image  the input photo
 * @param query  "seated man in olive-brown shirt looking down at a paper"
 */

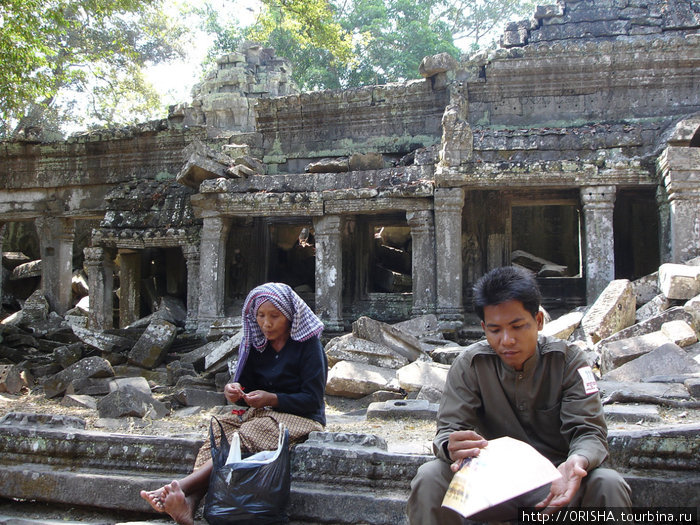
xmin=408 ymin=266 xmax=631 ymax=525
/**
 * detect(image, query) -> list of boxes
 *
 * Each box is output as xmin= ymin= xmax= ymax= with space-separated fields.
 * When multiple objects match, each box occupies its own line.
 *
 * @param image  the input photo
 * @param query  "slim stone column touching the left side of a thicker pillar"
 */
xmin=406 ymin=210 xmax=437 ymax=316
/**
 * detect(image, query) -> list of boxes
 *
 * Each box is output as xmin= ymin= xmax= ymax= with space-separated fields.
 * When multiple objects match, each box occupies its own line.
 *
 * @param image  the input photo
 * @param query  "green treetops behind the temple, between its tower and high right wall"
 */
xmin=200 ymin=0 xmax=532 ymax=90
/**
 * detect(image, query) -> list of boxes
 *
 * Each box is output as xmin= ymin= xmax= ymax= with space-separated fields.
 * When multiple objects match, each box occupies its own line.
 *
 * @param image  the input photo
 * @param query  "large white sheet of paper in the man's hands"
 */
xmin=442 ymin=437 xmax=561 ymax=518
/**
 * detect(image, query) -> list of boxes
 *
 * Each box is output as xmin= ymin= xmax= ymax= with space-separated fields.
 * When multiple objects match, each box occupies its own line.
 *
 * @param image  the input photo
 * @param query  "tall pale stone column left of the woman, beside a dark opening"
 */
xmin=197 ymin=217 xmax=231 ymax=331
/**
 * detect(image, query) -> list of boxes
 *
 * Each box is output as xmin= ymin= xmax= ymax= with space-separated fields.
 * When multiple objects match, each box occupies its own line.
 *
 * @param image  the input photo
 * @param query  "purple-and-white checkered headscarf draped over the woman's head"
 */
xmin=233 ymin=283 xmax=323 ymax=381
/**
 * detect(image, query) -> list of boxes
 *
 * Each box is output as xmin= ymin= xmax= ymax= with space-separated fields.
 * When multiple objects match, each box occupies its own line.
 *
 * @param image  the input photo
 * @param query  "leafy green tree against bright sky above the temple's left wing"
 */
xmin=0 ymin=0 xmax=187 ymax=137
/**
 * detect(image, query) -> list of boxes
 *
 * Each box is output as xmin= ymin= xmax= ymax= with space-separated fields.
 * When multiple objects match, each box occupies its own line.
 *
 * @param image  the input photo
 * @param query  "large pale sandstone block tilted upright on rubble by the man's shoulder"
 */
xmin=581 ymin=279 xmax=636 ymax=343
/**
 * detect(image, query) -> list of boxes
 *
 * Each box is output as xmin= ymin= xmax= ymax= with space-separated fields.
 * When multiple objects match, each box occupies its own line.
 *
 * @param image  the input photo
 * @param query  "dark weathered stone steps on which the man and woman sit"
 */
xmin=0 ymin=413 xmax=700 ymax=525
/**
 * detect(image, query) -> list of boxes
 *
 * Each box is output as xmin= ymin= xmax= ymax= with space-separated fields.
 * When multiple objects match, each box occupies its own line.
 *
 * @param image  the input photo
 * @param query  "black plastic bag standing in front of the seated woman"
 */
xmin=204 ymin=418 xmax=291 ymax=525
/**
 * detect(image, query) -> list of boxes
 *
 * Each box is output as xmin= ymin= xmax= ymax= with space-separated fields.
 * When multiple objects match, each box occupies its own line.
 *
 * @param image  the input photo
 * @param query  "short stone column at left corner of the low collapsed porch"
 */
xmin=83 ymin=248 xmax=114 ymax=330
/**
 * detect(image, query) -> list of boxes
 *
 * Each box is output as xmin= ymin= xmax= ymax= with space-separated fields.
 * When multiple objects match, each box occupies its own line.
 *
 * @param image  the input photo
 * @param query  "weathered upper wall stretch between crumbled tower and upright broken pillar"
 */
xmin=256 ymin=80 xmax=447 ymax=173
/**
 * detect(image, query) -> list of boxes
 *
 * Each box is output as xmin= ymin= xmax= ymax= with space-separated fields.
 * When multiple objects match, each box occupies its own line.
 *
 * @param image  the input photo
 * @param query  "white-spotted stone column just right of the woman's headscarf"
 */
xmin=314 ymin=215 xmax=343 ymax=332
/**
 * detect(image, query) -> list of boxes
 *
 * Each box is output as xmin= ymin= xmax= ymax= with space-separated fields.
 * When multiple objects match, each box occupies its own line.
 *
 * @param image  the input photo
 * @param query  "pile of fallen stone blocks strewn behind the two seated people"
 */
xmin=0 ymin=250 xmax=700 ymax=422
